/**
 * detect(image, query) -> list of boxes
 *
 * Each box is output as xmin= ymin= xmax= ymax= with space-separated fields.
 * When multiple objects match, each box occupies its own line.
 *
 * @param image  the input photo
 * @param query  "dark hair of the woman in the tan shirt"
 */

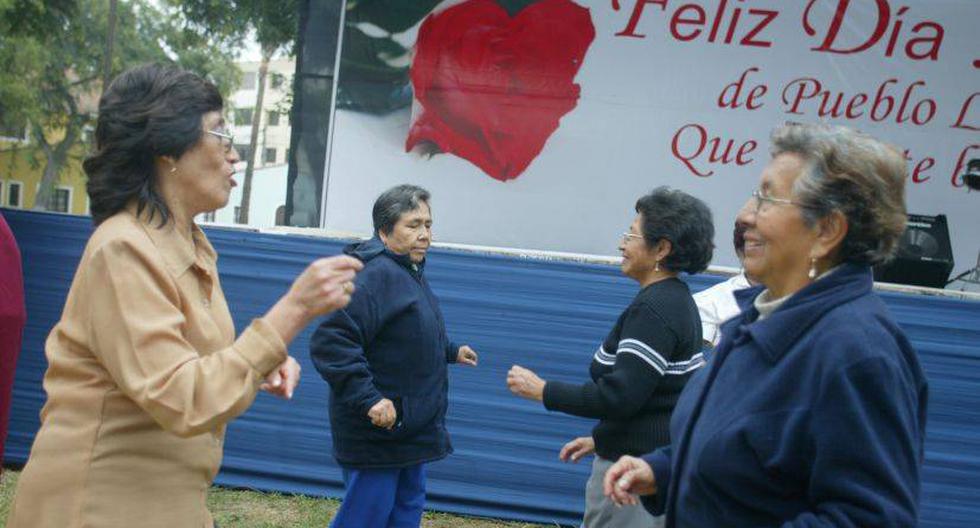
xmin=82 ymin=64 xmax=224 ymax=225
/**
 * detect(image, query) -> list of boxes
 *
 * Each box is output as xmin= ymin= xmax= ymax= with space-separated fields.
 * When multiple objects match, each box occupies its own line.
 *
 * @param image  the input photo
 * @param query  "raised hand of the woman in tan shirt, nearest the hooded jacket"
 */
xmin=286 ymin=256 xmax=364 ymax=318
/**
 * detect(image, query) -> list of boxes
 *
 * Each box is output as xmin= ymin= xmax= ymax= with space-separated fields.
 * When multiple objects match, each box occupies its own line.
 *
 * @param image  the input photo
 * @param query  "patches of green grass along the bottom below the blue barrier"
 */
xmin=0 ymin=470 xmax=542 ymax=528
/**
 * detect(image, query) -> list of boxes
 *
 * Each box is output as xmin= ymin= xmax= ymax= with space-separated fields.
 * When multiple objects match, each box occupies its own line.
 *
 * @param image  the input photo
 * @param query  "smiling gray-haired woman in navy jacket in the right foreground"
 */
xmin=604 ymin=124 xmax=927 ymax=527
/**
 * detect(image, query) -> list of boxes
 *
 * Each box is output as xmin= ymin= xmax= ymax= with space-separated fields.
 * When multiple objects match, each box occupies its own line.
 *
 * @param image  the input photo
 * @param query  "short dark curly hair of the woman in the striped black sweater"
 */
xmin=636 ymin=187 xmax=715 ymax=273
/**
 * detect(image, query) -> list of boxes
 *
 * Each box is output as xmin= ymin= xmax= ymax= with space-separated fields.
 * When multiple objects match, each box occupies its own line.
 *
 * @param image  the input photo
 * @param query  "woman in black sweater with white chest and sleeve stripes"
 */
xmin=507 ymin=187 xmax=714 ymax=528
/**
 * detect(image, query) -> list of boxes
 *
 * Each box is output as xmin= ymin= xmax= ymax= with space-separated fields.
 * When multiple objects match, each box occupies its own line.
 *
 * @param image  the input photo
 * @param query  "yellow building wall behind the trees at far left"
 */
xmin=0 ymin=142 xmax=88 ymax=215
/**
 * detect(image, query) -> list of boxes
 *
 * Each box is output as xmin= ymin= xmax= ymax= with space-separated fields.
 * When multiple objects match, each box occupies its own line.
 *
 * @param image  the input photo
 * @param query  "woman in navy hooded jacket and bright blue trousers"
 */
xmin=310 ymin=185 xmax=477 ymax=528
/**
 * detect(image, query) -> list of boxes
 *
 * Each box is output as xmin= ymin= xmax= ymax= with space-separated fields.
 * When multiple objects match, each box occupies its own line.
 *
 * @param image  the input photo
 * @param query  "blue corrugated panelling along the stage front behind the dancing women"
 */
xmin=4 ymin=210 xmax=980 ymax=528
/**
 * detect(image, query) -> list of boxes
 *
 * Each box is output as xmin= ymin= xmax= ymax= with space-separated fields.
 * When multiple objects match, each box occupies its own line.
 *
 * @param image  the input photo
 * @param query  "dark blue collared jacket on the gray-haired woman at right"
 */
xmin=644 ymin=264 xmax=928 ymax=527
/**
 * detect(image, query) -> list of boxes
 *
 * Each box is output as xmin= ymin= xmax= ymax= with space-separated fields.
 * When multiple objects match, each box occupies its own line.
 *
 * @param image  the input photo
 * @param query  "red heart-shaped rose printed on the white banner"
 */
xmin=405 ymin=0 xmax=595 ymax=181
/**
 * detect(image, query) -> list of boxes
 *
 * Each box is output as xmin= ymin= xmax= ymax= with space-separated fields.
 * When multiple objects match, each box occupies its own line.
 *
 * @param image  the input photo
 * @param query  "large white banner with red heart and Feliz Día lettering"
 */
xmin=324 ymin=0 xmax=980 ymax=271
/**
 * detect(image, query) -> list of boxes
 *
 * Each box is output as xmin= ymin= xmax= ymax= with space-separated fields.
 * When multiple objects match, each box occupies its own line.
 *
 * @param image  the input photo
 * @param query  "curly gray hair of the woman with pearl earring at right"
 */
xmin=770 ymin=123 xmax=907 ymax=264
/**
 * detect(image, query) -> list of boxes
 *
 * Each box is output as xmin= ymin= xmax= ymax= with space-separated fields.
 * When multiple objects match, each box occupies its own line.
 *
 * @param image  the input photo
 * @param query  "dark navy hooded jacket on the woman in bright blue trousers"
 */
xmin=310 ymin=238 xmax=459 ymax=468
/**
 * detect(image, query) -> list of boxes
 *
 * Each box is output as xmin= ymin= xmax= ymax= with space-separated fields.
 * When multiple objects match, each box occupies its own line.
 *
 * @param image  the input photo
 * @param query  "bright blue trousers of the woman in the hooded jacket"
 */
xmin=330 ymin=464 xmax=425 ymax=528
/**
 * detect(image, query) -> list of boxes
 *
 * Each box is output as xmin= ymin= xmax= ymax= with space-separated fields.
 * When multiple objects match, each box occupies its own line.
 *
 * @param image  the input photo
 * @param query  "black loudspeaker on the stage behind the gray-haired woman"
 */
xmin=874 ymin=214 xmax=953 ymax=288
